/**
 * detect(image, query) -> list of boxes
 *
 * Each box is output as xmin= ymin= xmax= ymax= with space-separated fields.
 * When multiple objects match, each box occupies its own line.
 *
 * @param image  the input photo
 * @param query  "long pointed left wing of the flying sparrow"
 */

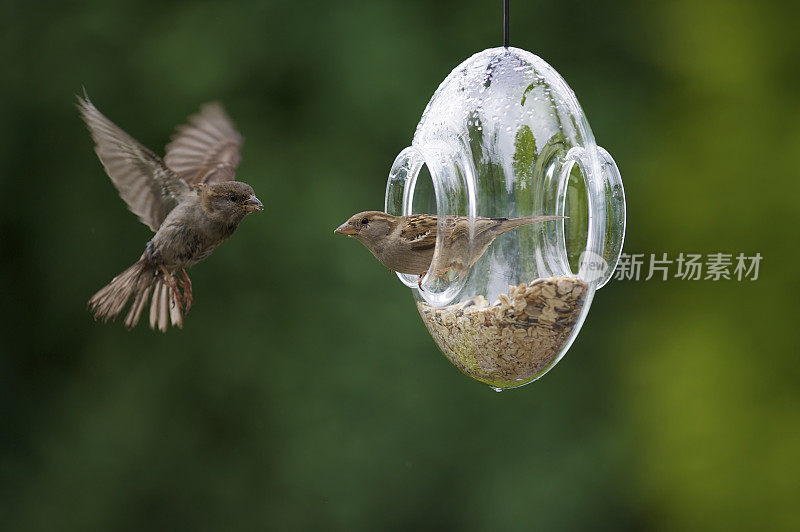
xmin=78 ymin=96 xmax=189 ymax=231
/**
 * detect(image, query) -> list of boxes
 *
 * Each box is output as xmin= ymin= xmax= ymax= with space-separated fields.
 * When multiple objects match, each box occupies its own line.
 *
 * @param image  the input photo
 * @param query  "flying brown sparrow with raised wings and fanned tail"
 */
xmin=78 ymin=96 xmax=264 ymax=332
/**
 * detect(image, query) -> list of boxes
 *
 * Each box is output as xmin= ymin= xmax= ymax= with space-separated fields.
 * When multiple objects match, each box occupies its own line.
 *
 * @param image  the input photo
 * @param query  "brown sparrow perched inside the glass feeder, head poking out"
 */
xmin=334 ymin=211 xmax=566 ymax=287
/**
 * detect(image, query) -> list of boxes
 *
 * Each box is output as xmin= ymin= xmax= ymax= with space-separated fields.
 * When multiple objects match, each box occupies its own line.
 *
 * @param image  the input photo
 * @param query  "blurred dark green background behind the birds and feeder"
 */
xmin=0 ymin=0 xmax=800 ymax=531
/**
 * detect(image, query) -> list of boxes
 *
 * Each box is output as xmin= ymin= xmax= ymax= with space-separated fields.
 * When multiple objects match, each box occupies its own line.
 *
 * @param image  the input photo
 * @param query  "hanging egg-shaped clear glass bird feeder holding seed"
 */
xmin=385 ymin=47 xmax=625 ymax=390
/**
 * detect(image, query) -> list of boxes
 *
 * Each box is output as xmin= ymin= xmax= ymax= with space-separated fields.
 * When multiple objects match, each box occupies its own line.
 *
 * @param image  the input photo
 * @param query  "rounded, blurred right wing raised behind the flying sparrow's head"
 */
xmin=164 ymin=102 xmax=242 ymax=185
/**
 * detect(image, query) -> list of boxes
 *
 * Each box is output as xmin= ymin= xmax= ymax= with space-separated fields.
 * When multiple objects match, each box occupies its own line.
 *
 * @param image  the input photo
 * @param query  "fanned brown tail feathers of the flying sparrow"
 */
xmin=89 ymin=260 xmax=183 ymax=332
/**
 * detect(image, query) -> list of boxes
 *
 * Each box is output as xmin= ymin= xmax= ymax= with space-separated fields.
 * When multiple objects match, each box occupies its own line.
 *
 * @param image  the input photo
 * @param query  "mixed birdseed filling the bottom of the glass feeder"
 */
xmin=417 ymin=277 xmax=588 ymax=388
